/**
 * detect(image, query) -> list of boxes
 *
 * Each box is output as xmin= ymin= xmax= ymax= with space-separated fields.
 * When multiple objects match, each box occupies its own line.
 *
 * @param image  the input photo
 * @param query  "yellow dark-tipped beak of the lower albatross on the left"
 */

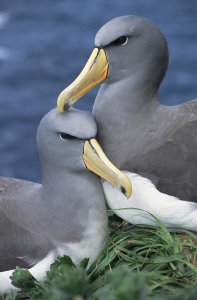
xmin=83 ymin=139 xmax=132 ymax=198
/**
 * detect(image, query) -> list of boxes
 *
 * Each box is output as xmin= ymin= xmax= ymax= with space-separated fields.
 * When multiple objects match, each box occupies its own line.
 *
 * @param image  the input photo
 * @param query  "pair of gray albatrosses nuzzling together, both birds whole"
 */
xmin=0 ymin=16 xmax=197 ymax=292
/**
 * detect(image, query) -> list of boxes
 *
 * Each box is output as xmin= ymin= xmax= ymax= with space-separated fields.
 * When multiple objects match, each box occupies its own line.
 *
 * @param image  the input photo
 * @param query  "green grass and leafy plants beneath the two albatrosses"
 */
xmin=1 ymin=215 xmax=197 ymax=300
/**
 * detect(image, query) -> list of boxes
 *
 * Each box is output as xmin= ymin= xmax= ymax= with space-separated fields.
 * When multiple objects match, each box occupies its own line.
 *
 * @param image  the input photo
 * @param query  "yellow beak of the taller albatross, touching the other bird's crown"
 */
xmin=57 ymin=48 xmax=108 ymax=112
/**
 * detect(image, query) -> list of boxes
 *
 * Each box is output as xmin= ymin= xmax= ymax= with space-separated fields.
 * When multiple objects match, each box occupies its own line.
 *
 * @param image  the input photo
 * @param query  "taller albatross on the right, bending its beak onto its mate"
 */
xmin=57 ymin=16 xmax=197 ymax=230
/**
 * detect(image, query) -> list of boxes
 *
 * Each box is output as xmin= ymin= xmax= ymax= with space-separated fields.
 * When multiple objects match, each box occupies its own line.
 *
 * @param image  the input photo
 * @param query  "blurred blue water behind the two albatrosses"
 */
xmin=0 ymin=0 xmax=197 ymax=181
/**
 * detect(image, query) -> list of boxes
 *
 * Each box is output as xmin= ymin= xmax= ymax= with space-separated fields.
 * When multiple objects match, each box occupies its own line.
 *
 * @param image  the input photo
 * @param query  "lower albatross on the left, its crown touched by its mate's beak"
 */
xmin=0 ymin=108 xmax=131 ymax=293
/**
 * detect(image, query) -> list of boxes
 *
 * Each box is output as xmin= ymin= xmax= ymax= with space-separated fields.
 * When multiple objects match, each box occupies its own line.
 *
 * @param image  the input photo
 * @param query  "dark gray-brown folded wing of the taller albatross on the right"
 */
xmin=131 ymin=109 xmax=197 ymax=202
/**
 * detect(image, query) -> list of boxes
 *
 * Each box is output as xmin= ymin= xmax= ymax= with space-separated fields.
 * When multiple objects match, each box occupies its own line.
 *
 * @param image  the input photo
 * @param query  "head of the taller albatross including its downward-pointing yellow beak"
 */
xmin=57 ymin=16 xmax=168 ymax=112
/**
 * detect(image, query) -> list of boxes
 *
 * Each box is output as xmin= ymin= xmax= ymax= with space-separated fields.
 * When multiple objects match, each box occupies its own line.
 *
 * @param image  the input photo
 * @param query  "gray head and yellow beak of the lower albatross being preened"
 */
xmin=37 ymin=108 xmax=131 ymax=198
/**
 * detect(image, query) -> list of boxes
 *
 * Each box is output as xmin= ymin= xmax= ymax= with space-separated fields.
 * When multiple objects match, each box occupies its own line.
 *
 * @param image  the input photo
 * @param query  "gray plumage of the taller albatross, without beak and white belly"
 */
xmin=93 ymin=16 xmax=197 ymax=202
